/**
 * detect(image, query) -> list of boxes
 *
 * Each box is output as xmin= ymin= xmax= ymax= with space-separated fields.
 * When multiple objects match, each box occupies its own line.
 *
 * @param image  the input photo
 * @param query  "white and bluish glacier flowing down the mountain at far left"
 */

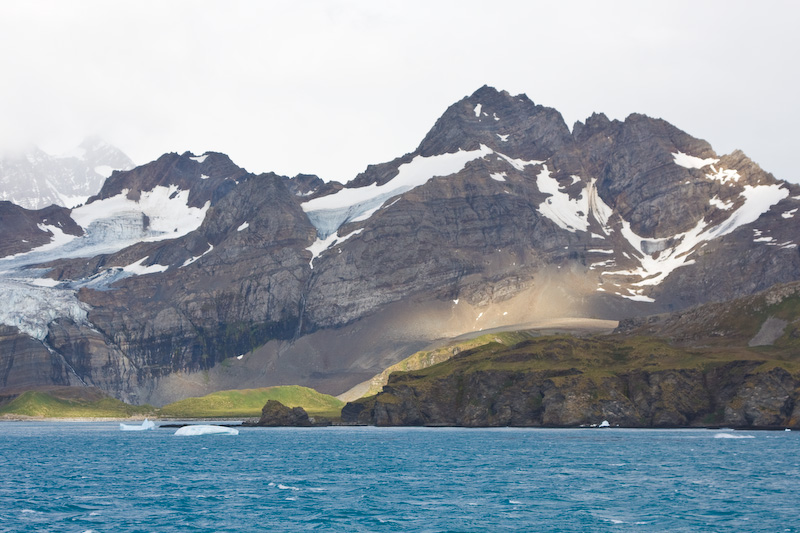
xmin=0 ymin=186 xmax=209 ymax=340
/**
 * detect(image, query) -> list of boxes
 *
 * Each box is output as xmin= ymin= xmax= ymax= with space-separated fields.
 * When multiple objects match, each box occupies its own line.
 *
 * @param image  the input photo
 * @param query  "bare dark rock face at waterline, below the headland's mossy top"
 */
xmin=342 ymin=354 xmax=800 ymax=428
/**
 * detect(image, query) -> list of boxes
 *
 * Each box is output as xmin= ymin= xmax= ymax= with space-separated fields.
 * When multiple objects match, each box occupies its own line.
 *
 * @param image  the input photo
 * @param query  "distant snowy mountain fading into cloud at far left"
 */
xmin=0 ymin=138 xmax=134 ymax=209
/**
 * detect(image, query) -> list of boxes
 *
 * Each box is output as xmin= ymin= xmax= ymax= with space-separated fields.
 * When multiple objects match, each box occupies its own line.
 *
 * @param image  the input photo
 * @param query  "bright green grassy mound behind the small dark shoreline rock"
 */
xmin=159 ymin=385 xmax=344 ymax=418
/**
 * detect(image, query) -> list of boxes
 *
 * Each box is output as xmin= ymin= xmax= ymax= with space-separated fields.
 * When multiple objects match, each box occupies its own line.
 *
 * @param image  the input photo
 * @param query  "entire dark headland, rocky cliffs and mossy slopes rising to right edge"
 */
xmin=342 ymin=282 xmax=800 ymax=428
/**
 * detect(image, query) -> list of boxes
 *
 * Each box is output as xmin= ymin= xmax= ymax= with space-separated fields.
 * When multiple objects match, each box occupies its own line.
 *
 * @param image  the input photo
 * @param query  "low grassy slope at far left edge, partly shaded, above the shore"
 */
xmin=0 ymin=387 xmax=155 ymax=418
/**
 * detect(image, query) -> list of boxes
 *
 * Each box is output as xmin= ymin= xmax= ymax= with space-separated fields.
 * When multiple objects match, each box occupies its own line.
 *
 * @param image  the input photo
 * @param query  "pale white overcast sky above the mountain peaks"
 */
xmin=0 ymin=0 xmax=800 ymax=182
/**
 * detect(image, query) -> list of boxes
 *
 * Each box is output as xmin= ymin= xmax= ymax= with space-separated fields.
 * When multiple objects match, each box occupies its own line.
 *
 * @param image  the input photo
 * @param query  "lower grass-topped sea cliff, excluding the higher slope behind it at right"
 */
xmin=342 ymin=337 xmax=800 ymax=428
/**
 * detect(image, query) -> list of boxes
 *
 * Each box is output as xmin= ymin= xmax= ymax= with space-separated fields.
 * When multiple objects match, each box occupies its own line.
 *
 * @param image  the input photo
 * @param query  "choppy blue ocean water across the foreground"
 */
xmin=0 ymin=422 xmax=800 ymax=532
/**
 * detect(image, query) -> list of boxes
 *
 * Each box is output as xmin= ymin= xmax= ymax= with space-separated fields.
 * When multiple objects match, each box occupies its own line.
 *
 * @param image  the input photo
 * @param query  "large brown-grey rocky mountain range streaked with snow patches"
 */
xmin=0 ymin=87 xmax=800 ymax=405
